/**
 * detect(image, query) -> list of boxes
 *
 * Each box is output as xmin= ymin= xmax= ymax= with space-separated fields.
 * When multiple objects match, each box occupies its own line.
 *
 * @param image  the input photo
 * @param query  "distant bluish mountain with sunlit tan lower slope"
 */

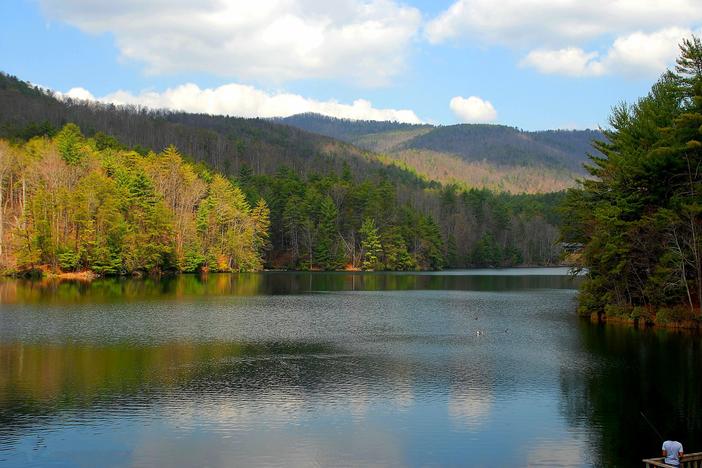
xmin=275 ymin=114 xmax=604 ymax=192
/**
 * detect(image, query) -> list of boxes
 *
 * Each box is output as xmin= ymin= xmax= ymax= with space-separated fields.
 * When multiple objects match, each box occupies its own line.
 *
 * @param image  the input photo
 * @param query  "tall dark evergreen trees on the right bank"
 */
xmin=563 ymin=37 xmax=702 ymax=323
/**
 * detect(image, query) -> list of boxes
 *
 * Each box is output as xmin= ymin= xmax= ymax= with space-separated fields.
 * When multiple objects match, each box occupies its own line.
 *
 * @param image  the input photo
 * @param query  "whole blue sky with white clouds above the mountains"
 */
xmin=0 ymin=0 xmax=702 ymax=130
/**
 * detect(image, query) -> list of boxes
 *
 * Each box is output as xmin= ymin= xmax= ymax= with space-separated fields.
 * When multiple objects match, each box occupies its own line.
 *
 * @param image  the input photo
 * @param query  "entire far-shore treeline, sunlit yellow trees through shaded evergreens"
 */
xmin=0 ymin=124 xmax=560 ymax=274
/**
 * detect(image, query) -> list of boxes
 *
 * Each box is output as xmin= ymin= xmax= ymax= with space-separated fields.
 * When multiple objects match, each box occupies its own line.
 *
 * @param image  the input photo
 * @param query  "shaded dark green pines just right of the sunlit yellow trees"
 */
xmin=239 ymin=167 xmax=446 ymax=270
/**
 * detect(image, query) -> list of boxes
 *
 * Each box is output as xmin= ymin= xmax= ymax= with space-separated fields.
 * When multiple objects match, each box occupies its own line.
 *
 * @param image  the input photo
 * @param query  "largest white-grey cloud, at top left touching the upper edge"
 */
xmin=40 ymin=0 xmax=421 ymax=85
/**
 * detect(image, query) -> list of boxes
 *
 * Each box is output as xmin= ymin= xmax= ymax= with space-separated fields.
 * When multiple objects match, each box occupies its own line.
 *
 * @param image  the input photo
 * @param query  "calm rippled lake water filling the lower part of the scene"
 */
xmin=0 ymin=269 xmax=702 ymax=467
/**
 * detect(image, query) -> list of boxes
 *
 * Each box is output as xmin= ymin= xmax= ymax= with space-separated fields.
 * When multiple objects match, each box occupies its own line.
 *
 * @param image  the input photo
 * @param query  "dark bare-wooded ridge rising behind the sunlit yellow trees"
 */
xmin=0 ymin=73 xmax=422 ymax=184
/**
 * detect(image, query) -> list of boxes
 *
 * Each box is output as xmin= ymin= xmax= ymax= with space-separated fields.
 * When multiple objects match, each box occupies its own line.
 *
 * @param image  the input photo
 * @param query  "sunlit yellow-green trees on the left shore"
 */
xmin=0 ymin=124 xmax=269 ymax=274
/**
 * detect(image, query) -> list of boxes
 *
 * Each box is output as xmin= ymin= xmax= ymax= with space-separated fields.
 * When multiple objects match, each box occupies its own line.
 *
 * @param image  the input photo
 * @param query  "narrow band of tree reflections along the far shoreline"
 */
xmin=0 ymin=272 xmax=574 ymax=304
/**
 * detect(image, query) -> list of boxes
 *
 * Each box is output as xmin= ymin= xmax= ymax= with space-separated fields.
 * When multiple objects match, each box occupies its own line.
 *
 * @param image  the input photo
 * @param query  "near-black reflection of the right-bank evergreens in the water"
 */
xmin=561 ymin=323 xmax=702 ymax=466
